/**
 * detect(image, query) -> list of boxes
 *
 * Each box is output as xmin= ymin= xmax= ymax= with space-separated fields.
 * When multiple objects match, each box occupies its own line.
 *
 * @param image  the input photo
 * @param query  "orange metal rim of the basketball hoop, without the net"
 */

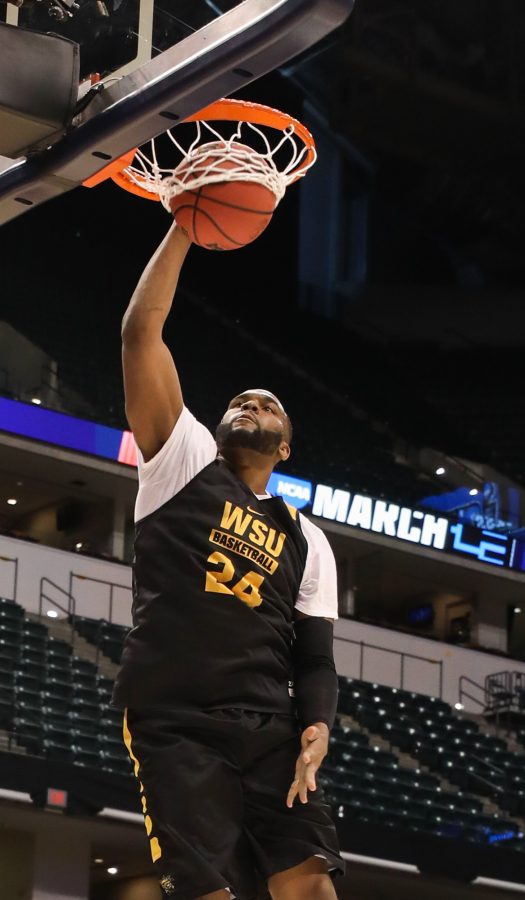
xmin=83 ymin=99 xmax=315 ymax=200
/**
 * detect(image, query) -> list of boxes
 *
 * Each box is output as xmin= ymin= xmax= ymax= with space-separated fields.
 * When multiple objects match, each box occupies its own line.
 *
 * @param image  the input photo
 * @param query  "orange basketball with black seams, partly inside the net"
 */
xmin=170 ymin=142 xmax=277 ymax=250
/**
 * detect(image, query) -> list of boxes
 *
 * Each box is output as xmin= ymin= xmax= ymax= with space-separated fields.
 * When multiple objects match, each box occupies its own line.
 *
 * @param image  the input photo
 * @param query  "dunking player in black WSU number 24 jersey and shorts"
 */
xmin=114 ymin=223 xmax=344 ymax=900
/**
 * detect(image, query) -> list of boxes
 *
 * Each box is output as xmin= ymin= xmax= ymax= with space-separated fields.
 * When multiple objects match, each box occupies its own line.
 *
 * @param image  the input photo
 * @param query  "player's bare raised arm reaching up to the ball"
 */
xmin=122 ymin=223 xmax=190 ymax=461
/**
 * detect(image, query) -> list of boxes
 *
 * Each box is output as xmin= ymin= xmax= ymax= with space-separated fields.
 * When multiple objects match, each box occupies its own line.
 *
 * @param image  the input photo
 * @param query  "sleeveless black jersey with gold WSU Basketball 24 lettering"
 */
xmin=113 ymin=459 xmax=307 ymax=714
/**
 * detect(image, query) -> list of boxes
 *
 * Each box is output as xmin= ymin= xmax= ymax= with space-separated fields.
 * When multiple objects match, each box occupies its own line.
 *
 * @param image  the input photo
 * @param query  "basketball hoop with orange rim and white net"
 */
xmin=84 ymin=99 xmax=317 ymax=211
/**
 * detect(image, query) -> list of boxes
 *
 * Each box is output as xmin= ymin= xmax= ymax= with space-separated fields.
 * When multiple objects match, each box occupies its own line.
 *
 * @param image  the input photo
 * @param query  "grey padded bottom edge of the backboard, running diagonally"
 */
xmin=0 ymin=0 xmax=354 ymax=224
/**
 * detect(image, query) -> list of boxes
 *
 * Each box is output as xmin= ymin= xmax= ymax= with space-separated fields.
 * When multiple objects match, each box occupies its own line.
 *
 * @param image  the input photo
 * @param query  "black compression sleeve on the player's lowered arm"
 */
xmin=292 ymin=616 xmax=338 ymax=729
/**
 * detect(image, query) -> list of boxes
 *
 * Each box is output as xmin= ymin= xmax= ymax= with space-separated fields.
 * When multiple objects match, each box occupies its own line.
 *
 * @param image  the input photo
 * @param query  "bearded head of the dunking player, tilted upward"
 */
xmin=215 ymin=388 xmax=292 ymax=465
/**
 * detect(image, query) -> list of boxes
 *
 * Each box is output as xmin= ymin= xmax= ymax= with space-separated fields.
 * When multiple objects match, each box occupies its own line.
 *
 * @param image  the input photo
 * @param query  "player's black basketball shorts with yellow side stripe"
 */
xmin=124 ymin=709 xmax=345 ymax=900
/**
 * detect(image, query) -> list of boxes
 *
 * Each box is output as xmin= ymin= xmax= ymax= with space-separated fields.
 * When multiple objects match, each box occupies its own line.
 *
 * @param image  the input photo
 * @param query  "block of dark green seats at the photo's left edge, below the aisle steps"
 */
xmin=0 ymin=598 xmax=131 ymax=774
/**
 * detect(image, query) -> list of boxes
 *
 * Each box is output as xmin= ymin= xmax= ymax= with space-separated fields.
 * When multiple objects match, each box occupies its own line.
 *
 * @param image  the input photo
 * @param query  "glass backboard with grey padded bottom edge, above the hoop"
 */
xmin=0 ymin=0 xmax=354 ymax=224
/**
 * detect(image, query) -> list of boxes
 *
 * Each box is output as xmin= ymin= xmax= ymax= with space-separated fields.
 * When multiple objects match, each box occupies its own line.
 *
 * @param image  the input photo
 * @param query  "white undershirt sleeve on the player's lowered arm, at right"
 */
xmin=295 ymin=513 xmax=338 ymax=619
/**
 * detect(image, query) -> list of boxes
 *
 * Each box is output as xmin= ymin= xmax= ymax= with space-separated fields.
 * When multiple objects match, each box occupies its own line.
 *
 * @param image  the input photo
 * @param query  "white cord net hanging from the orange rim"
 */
xmin=118 ymin=120 xmax=316 ymax=211
